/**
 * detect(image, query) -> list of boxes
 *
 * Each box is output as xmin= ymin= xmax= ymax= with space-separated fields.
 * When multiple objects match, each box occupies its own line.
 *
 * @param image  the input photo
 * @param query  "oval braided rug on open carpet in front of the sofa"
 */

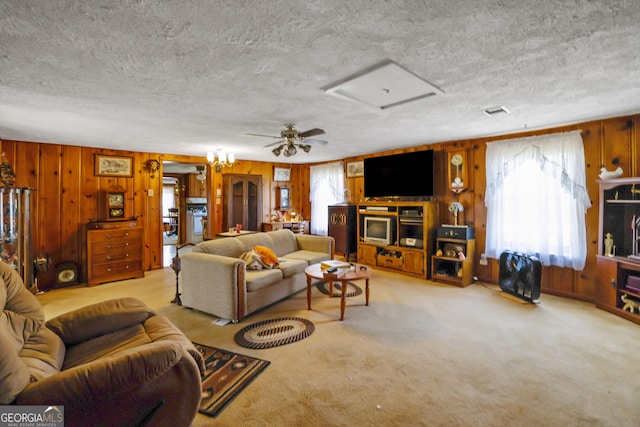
xmin=235 ymin=317 xmax=315 ymax=349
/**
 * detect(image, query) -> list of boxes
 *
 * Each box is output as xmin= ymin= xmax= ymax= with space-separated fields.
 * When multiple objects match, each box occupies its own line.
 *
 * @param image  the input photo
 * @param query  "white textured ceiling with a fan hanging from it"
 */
xmin=0 ymin=0 xmax=640 ymax=163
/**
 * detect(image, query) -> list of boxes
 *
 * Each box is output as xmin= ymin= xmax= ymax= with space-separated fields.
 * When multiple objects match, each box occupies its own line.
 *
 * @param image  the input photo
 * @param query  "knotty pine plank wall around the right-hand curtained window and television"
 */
xmin=345 ymin=115 xmax=640 ymax=301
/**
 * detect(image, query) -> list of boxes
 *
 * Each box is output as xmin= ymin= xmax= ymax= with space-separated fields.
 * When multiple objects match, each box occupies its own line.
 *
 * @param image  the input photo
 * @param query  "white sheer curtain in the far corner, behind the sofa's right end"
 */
xmin=309 ymin=162 xmax=344 ymax=236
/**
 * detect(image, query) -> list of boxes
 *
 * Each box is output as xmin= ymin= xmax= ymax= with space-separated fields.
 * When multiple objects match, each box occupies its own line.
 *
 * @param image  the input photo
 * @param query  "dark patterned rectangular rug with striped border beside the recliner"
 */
xmin=193 ymin=343 xmax=271 ymax=417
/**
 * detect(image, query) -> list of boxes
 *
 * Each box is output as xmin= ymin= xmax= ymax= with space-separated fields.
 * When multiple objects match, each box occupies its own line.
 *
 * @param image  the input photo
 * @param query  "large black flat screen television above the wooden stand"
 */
xmin=364 ymin=150 xmax=435 ymax=199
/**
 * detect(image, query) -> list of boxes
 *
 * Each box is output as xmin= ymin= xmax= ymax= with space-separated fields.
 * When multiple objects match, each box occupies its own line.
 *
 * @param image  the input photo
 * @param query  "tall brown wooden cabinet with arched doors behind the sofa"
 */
xmin=222 ymin=174 xmax=262 ymax=231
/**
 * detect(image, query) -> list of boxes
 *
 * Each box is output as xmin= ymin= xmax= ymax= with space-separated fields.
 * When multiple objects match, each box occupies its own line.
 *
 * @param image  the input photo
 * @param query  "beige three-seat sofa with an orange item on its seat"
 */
xmin=180 ymin=230 xmax=334 ymax=322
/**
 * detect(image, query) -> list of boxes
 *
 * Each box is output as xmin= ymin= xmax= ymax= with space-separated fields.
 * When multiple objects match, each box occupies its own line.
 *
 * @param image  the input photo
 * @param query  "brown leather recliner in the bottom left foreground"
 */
xmin=0 ymin=262 xmax=204 ymax=426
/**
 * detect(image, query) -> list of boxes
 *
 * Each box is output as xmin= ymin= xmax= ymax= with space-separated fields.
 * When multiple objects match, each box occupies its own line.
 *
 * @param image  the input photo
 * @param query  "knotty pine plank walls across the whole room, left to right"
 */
xmin=0 ymin=115 xmax=640 ymax=301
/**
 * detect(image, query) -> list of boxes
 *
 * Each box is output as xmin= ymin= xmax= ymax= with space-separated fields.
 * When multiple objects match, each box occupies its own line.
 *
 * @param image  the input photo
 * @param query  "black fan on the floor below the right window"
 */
xmin=499 ymin=251 xmax=542 ymax=302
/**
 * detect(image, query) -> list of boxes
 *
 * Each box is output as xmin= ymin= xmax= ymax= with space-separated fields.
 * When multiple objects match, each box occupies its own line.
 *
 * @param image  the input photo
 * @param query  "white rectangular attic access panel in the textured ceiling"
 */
xmin=322 ymin=60 xmax=444 ymax=110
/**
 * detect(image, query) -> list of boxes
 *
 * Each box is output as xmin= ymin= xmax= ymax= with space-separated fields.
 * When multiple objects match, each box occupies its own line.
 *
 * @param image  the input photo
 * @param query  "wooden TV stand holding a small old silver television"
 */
xmin=357 ymin=201 xmax=438 ymax=279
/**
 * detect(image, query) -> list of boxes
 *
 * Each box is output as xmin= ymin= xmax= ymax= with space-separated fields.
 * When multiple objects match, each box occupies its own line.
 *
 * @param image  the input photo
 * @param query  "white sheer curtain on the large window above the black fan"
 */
xmin=485 ymin=131 xmax=591 ymax=270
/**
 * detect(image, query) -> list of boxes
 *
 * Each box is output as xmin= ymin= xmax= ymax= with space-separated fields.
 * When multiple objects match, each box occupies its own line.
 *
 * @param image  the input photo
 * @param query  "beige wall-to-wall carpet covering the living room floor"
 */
xmin=38 ymin=269 xmax=640 ymax=427
